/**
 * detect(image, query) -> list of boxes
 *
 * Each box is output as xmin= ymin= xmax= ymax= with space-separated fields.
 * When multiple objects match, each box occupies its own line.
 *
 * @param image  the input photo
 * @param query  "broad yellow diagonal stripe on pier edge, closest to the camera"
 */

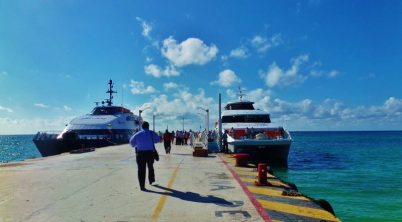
xmin=257 ymin=199 xmax=340 ymax=221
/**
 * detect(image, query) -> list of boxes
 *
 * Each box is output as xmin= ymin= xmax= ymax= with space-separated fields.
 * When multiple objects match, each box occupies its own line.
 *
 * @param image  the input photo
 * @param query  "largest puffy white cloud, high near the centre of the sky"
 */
xmin=162 ymin=36 xmax=218 ymax=67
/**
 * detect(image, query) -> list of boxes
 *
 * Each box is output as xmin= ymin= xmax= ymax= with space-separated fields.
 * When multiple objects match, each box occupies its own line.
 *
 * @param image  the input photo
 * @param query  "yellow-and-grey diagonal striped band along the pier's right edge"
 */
xmin=220 ymin=156 xmax=340 ymax=222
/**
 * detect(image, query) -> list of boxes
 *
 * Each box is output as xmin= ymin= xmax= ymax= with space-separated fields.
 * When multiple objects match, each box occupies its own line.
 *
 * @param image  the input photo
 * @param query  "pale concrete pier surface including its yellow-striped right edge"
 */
xmin=0 ymin=144 xmax=338 ymax=222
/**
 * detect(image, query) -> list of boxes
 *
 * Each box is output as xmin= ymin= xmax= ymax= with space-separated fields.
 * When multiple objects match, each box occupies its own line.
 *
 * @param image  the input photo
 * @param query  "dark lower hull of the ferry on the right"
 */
xmin=228 ymin=140 xmax=291 ymax=166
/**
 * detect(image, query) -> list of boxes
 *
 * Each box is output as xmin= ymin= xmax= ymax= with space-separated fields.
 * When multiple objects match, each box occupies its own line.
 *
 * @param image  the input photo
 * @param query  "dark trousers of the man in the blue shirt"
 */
xmin=137 ymin=150 xmax=155 ymax=189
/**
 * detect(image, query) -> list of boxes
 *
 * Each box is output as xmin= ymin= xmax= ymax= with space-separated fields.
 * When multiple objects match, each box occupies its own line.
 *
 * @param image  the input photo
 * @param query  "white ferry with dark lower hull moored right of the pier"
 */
xmin=222 ymin=90 xmax=292 ymax=166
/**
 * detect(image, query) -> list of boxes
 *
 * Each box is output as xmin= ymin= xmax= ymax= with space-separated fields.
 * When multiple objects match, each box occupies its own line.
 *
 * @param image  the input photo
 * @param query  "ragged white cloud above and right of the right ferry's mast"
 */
xmin=260 ymin=55 xmax=309 ymax=87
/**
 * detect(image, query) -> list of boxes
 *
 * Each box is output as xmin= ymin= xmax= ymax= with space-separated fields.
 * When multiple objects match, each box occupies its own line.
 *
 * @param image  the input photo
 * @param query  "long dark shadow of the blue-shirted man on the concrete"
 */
xmin=146 ymin=185 xmax=239 ymax=207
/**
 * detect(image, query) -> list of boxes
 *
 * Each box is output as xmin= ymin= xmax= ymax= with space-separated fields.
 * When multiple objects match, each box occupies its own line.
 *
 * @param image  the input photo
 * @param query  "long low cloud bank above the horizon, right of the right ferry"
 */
xmin=254 ymin=95 xmax=402 ymax=130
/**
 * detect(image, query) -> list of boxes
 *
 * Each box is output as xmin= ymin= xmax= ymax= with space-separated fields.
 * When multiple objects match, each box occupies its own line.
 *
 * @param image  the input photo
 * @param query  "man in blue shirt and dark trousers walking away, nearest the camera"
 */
xmin=130 ymin=121 xmax=160 ymax=190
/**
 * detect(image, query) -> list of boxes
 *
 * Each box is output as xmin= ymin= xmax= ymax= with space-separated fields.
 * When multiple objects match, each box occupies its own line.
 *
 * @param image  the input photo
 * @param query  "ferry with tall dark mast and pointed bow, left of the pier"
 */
xmin=33 ymin=80 xmax=142 ymax=156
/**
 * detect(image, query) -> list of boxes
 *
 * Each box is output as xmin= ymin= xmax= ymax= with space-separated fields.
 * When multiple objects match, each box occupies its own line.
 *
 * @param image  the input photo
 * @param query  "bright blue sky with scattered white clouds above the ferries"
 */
xmin=0 ymin=0 xmax=402 ymax=134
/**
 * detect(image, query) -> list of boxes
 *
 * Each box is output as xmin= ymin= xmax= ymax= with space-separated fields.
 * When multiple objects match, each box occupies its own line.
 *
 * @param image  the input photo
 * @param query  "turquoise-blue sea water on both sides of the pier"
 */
xmin=0 ymin=131 xmax=402 ymax=222
